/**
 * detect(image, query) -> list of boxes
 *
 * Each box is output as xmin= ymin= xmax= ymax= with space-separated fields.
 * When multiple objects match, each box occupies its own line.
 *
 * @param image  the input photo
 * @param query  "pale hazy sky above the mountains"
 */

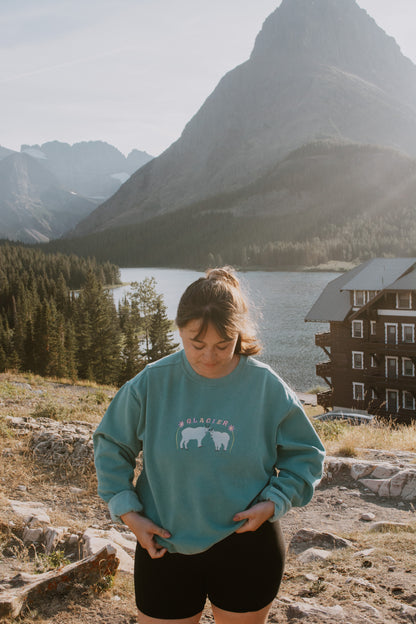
xmin=0 ymin=0 xmax=416 ymax=156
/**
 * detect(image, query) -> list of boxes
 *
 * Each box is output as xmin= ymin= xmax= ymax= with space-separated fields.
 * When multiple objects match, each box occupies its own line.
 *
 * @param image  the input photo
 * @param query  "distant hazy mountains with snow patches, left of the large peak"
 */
xmin=0 ymin=141 xmax=152 ymax=243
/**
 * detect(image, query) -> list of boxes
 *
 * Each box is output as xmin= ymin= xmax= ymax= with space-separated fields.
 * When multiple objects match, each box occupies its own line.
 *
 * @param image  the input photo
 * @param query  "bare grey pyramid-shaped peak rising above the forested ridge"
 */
xmin=75 ymin=0 xmax=416 ymax=246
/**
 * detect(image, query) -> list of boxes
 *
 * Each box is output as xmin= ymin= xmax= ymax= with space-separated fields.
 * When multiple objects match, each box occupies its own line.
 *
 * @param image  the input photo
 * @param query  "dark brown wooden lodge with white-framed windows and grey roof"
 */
xmin=305 ymin=258 xmax=416 ymax=423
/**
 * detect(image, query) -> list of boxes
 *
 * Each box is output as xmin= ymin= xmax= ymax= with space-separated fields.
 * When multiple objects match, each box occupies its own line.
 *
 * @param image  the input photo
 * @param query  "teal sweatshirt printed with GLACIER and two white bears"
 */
xmin=94 ymin=351 xmax=324 ymax=554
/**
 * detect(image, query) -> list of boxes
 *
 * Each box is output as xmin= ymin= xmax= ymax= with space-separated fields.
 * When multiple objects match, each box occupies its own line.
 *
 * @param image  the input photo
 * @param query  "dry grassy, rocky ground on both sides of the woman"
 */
xmin=0 ymin=373 xmax=416 ymax=624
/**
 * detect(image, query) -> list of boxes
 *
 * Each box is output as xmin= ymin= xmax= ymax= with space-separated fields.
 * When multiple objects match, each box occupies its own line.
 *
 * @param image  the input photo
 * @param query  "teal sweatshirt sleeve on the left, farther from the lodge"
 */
xmin=93 ymin=381 xmax=144 ymax=522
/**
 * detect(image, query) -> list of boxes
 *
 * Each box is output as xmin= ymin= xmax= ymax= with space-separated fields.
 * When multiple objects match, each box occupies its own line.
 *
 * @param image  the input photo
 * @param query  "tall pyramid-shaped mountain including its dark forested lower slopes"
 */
xmin=67 ymin=0 xmax=416 ymax=265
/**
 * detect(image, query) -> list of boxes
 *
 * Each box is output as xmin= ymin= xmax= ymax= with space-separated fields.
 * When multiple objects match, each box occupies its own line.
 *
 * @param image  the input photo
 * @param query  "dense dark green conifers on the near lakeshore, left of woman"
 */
xmin=0 ymin=241 xmax=178 ymax=385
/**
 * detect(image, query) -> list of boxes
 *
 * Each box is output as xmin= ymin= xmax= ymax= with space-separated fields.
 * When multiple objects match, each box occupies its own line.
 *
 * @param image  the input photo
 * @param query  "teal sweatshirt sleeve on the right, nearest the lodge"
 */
xmin=257 ymin=399 xmax=325 ymax=522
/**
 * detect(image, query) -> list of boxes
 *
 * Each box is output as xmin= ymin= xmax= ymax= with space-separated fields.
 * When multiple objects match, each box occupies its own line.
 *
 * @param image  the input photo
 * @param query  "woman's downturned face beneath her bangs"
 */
xmin=179 ymin=319 xmax=240 ymax=379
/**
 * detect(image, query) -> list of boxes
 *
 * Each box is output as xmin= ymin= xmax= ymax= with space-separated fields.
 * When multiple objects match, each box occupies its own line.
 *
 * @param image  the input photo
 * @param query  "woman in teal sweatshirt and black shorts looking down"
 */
xmin=94 ymin=268 xmax=324 ymax=624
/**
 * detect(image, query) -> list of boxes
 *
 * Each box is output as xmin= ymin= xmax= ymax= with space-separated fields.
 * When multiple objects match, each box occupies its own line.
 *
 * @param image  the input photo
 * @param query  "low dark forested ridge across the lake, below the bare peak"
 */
xmin=47 ymin=141 xmax=416 ymax=268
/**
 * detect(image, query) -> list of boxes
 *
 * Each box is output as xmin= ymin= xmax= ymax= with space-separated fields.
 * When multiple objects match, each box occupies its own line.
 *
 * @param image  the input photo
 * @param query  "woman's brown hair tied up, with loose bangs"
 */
xmin=176 ymin=267 xmax=261 ymax=355
